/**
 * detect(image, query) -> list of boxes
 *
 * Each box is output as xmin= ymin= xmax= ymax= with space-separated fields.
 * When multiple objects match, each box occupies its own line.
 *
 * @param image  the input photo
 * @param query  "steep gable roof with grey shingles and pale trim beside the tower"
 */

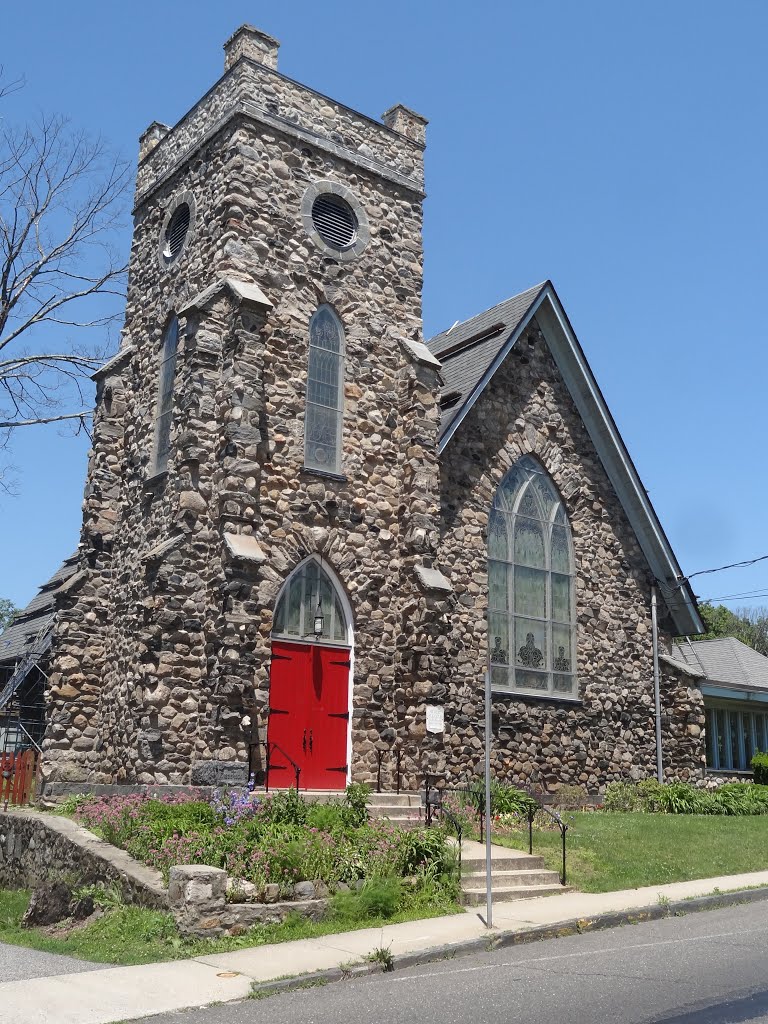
xmin=427 ymin=281 xmax=703 ymax=635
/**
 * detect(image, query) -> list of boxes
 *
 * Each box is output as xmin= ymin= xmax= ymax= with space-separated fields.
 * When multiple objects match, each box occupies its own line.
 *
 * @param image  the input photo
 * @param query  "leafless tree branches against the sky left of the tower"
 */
xmin=0 ymin=75 xmax=130 ymax=464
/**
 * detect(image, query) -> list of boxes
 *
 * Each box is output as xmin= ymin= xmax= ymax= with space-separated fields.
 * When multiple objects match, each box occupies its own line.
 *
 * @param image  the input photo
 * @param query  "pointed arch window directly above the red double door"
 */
xmin=272 ymin=558 xmax=349 ymax=644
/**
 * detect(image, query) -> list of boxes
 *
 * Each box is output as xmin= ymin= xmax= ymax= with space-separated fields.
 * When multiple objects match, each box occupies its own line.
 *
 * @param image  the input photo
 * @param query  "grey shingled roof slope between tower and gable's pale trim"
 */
xmin=427 ymin=282 xmax=547 ymax=438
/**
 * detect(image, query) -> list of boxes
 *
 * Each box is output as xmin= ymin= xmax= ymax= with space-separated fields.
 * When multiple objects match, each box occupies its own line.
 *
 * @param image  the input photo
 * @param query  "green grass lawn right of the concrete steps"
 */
xmin=494 ymin=811 xmax=768 ymax=893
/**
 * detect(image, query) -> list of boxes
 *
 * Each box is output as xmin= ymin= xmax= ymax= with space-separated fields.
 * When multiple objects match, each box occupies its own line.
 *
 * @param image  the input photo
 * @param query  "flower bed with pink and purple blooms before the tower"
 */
xmin=69 ymin=785 xmax=452 ymax=900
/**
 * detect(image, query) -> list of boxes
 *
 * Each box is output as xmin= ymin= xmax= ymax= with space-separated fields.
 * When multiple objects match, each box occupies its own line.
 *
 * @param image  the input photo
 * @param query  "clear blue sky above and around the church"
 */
xmin=0 ymin=0 xmax=768 ymax=605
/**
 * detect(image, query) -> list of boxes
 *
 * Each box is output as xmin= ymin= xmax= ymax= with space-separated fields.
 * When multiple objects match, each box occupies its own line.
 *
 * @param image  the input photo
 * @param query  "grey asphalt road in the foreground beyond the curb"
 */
xmin=140 ymin=902 xmax=768 ymax=1024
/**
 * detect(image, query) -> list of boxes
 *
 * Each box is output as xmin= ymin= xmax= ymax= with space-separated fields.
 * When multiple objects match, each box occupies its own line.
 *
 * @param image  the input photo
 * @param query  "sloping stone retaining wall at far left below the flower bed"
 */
xmin=0 ymin=811 xmax=168 ymax=908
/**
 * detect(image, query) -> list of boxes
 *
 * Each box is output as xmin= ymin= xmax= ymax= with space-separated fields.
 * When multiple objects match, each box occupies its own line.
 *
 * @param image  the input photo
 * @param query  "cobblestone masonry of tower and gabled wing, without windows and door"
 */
xmin=43 ymin=22 xmax=702 ymax=793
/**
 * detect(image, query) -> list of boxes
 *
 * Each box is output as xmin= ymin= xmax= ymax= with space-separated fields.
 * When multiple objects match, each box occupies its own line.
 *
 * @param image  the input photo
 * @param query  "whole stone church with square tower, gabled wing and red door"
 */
xmin=37 ymin=26 xmax=703 ymax=796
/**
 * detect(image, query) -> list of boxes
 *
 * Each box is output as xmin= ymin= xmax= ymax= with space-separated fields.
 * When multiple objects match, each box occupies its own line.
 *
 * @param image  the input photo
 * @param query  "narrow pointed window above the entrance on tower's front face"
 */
xmin=304 ymin=305 xmax=344 ymax=473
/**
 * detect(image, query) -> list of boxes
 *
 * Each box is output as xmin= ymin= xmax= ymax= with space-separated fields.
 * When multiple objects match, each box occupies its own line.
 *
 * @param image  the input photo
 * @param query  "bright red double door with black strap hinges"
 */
xmin=267 ymin=641 xmax=349 ymax=790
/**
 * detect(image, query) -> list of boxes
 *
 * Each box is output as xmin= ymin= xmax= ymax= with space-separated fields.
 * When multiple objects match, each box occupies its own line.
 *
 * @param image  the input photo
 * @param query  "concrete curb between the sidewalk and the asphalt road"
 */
xmin=253 ymin=886 xmax=768 ymax=998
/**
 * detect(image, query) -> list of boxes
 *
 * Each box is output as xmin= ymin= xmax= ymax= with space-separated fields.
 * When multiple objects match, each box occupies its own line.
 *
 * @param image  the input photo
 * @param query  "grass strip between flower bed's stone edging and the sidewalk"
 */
xmin=0 ymin=889 xmax=463 ymax=965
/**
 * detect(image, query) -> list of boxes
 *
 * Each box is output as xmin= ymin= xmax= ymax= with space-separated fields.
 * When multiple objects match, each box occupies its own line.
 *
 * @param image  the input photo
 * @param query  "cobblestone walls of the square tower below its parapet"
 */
xmin=43 ymin=32 xmax=439 ymax=784
